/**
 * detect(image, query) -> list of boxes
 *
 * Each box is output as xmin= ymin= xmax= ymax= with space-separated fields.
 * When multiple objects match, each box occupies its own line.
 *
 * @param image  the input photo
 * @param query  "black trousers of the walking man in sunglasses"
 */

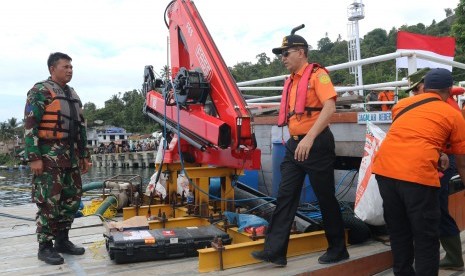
xmin=265 ymin=128 xmax=346 ymax=259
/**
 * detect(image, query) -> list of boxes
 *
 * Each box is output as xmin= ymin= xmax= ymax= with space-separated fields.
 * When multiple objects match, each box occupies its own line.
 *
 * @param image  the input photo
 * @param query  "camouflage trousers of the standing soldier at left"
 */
xmin=32 ymin=167 xmax=82 ymax=242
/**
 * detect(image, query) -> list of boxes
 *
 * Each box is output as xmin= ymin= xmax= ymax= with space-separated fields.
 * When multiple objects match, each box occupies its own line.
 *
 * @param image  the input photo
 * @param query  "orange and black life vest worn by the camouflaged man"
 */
xmin=38 ymin=80 xmax=84 ymax=140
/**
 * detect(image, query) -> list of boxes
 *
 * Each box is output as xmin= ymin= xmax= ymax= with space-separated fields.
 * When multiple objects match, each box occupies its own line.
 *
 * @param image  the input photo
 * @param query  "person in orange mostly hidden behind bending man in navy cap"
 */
xmin=406 ymin=68 xmax=465 ymax=271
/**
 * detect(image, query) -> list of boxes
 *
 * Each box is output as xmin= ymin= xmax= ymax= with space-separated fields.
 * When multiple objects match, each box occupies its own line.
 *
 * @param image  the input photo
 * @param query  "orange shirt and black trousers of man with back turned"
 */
xmin=373 ymin=91 xmax=465 ymax=275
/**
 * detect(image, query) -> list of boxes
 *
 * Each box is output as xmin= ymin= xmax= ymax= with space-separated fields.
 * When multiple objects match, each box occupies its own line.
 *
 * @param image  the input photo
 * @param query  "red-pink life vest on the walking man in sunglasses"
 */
xmin=278 ymin=63 xmax=328 ymax=126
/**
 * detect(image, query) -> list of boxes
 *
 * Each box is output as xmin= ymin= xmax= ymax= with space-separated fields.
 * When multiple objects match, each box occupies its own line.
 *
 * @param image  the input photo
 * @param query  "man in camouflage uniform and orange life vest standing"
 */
xmin=24 ymin=53 xmax=89 ymax=265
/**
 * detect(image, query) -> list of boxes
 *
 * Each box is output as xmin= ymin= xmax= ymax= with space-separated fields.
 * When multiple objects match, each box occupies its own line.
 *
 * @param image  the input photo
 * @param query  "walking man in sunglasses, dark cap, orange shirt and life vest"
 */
xmin=252 ymin=29 xmax=349 ymax=266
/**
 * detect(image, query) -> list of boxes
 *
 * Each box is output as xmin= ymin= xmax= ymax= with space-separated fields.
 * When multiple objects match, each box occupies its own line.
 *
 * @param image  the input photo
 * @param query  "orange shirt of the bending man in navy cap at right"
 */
xmin=373 ymin=93 xmax=465 ymax=187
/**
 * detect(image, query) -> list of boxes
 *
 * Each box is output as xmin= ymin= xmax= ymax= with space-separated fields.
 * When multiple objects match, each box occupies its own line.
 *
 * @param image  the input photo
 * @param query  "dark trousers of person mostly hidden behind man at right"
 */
xmin=439 ymin=155 xmax=460 ymax=237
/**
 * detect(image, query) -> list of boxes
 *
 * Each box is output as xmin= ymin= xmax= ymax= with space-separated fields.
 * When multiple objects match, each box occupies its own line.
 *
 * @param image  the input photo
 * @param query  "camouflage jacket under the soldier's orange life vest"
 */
xmin=24 ymin=78 xmax=89 ymax=168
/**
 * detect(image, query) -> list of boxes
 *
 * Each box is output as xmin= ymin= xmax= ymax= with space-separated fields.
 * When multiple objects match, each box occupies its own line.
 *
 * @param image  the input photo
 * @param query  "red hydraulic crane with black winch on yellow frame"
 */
xmin=143 ymin=0 xmax=260 ymax=169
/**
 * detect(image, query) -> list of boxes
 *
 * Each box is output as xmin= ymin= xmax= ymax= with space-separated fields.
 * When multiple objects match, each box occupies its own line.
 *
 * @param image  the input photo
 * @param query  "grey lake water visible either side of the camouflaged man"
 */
xmin=0 ymin=167 xmax=155 ymax=207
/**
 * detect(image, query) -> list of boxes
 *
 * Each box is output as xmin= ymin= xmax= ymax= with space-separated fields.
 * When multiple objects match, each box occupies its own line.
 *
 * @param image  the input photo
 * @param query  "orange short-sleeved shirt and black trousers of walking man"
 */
xmin=264 ymin=64 xmax=346 ymax=261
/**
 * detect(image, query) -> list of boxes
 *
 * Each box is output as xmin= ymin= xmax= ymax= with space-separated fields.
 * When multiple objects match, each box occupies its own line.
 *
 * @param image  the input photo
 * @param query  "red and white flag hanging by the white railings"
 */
xmin=396 ymin=31 xmax=455 ymax=71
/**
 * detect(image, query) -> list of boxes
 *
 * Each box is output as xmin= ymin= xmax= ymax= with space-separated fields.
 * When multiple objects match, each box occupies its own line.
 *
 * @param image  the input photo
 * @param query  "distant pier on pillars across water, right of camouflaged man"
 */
xmin=91 ymin=151 xmax=157 ymax=168
